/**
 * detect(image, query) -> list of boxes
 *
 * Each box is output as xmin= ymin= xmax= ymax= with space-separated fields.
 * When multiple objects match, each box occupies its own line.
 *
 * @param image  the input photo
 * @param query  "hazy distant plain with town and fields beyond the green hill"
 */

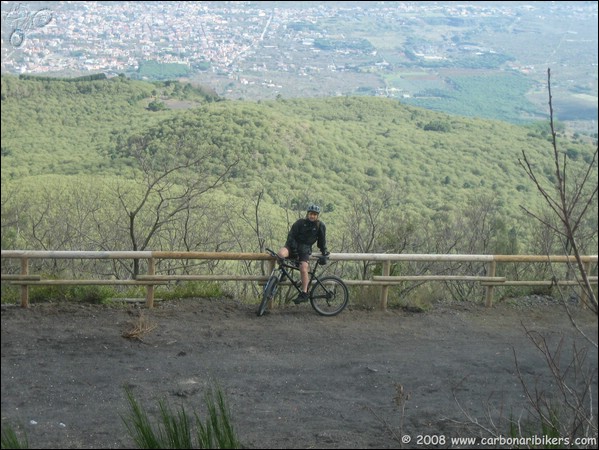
xmin=1 ymin=1 xmax=598 ymax=128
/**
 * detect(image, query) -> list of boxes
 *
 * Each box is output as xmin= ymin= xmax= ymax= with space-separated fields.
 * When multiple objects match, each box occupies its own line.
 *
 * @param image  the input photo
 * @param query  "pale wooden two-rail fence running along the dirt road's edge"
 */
xmin=1 ymin=250 xmax=597 ymax=309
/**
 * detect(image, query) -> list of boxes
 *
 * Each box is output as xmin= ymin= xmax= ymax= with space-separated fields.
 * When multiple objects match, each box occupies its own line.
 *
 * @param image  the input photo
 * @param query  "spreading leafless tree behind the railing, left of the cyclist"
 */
xmin=111 ymin=124 xmax=239 ymax=276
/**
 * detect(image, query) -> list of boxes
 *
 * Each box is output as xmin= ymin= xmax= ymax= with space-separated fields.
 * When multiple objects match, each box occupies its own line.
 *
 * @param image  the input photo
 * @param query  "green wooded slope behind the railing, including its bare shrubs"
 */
xmin=1 ymin=76 xmax=597 ymax=268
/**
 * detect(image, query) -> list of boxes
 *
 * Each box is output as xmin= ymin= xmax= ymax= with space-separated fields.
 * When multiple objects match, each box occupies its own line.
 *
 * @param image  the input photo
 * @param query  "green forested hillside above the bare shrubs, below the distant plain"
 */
xmin=1 ymin=76 xmax=597 ymax=251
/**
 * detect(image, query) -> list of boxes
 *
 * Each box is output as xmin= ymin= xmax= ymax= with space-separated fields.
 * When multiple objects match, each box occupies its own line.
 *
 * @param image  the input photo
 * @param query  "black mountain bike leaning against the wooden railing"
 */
xmin=256 ymin=248 xmax=349 ymax=316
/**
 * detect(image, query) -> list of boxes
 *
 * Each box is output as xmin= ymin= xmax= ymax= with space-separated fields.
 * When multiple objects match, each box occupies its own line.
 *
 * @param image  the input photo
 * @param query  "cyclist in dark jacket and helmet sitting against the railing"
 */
xmin=278 ymin=204 xmax=329 ymax=305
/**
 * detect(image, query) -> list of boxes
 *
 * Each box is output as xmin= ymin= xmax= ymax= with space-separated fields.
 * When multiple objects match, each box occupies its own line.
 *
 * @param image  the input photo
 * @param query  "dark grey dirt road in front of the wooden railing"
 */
xmin=2 ymin=299 xmax=597 ymax=448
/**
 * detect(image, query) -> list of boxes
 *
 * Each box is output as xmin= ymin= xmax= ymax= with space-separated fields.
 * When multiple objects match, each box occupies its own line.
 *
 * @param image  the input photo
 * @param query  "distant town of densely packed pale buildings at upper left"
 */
xmin=2 ymin=1 xmax=528 ymax=73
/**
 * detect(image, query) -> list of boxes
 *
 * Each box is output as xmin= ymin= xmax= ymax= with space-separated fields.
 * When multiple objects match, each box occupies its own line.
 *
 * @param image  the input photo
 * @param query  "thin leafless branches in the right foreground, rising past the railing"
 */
xmin=458 ymin=70 xmax=597 ymax=448
